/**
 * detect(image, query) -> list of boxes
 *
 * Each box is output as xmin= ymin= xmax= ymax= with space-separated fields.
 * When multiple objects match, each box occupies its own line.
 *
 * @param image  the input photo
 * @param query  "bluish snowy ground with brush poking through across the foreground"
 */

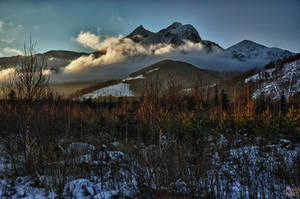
xmin=0 ymin=136 xmax=299 ymax=199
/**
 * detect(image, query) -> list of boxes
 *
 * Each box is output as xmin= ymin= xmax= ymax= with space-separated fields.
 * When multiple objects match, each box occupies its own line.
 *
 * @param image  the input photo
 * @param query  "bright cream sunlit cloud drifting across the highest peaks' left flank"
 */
xmin=64 ymin=31 xmax=203 ymax=73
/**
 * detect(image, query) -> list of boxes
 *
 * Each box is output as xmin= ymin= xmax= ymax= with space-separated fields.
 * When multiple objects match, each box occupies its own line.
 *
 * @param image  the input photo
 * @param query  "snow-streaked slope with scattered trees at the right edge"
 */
xmin=245 ymin=54 xmax=300 ymax=99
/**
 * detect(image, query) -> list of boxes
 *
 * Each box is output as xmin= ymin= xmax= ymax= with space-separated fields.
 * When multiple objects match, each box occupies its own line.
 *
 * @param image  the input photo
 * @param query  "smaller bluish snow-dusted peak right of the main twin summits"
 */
xmin=225 ymin=40 xmax=294 ymax=62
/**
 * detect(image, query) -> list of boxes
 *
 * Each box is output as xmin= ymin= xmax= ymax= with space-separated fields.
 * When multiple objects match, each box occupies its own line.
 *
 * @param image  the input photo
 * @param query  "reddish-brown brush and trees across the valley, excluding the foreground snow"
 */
xmin=0 ymin=80 xmax=300 ymax=198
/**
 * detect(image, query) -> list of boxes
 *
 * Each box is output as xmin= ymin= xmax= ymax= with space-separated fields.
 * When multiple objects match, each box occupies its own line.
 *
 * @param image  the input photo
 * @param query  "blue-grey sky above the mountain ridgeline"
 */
xmin=0 ymin=0 xmax=300 ymax=56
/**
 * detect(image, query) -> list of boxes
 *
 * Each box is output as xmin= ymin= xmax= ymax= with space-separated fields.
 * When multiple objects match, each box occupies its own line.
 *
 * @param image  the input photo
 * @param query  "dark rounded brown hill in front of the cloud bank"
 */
xmin=122 ymin=60 xmax=223 ymax=93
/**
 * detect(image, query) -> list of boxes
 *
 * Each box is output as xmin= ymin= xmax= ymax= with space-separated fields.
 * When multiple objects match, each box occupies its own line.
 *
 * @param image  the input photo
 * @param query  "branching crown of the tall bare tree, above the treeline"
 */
xmin=12 ymin=37 xmax=50 ymax=101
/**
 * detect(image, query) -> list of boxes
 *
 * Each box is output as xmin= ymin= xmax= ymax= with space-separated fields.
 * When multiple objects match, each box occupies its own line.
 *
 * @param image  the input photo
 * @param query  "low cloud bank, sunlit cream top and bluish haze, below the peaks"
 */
xmin=52 ymin=31 xmax=262 ymax=82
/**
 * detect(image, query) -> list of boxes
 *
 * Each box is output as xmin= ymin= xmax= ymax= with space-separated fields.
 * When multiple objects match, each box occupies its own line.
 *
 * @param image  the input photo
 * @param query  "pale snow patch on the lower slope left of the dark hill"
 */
xmin=80 ymin=83 xmax=134 ymax=99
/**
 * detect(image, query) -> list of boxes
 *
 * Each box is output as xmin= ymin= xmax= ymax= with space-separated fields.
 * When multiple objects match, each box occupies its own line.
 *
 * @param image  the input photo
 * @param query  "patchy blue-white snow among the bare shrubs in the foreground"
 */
xmin=0 ymin=135 xmax=299 ymax=199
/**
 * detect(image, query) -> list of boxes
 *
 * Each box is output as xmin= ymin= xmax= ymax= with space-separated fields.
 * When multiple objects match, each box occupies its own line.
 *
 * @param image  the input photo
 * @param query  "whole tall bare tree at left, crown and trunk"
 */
xmin=3 ymin=38 xmax=50 ymax=173
